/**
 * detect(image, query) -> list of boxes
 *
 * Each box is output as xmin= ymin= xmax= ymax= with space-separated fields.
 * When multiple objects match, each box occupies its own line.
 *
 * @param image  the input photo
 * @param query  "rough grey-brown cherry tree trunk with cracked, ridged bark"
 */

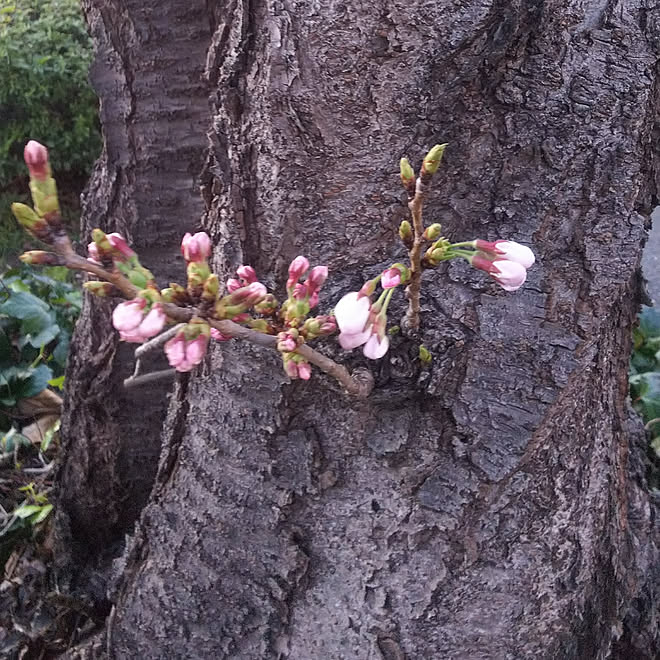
xmin=58 ymin=0 xmax=660 ymax=660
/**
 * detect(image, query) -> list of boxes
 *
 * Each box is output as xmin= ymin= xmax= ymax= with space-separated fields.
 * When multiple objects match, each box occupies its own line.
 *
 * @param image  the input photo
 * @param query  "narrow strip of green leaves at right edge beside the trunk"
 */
xmin=630 ymin=307 xmax=660 ymax=470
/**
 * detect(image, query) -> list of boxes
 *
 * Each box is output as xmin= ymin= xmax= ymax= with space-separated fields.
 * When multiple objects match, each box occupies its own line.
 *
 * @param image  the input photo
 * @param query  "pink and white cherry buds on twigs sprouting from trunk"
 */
xmin=12 ymin=141 xmax=535 ymax=390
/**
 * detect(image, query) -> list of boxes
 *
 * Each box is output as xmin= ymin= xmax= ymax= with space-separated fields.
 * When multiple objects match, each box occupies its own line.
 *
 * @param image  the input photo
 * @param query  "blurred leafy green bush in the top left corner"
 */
xmin=0 ymin=0 xmax=101 ymax=184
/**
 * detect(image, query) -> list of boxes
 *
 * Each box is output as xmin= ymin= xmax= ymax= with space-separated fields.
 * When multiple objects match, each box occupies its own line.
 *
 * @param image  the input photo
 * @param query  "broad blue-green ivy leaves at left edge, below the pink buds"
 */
xmin=0 ymin=266 xmax=82 ymax=429
